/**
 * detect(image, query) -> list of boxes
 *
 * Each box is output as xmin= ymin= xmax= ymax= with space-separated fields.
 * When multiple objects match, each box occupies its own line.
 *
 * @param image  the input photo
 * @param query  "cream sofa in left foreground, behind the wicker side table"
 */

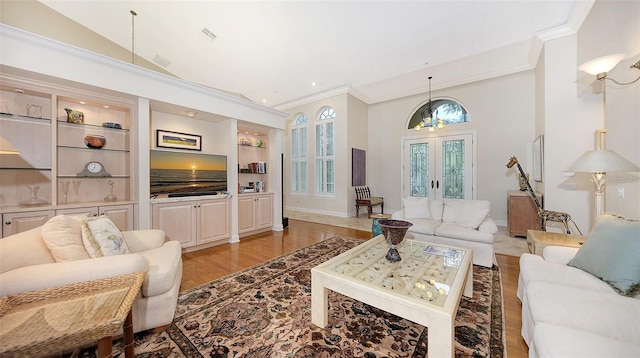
xmin=0 ymin=214 xmax=182 ymax=332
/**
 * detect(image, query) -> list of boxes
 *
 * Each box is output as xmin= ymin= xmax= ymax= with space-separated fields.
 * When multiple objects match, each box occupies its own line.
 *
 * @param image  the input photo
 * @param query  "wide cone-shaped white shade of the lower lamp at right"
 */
xmin=564 ymin=149 xmax=640 ymax=173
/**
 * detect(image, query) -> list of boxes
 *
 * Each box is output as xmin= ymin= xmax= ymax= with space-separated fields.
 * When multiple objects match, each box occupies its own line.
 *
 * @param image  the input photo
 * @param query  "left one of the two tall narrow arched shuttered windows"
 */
xmin=291 ymin=113 xmax=308 ymax=193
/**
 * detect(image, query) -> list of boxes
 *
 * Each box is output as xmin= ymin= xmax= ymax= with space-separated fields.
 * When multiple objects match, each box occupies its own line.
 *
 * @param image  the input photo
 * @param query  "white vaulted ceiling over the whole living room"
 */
xmin=41 ymin=0 xmax=593 ymax=108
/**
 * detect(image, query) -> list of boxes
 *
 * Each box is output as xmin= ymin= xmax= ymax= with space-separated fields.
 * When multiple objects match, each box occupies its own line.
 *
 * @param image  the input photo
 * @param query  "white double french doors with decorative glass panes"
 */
xmin=402 ymin=133 xmax=475 ymax=199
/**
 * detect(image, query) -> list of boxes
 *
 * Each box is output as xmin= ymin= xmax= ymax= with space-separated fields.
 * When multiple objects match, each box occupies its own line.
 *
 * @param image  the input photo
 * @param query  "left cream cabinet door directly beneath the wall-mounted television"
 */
xmin=152 ymin=201 xmax=197 ymax=247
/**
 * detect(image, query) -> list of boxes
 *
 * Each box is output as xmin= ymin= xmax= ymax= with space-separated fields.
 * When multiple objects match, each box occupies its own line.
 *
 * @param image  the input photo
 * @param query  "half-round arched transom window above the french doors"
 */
xmin=407 ymin=98 xmax=469 ymax=129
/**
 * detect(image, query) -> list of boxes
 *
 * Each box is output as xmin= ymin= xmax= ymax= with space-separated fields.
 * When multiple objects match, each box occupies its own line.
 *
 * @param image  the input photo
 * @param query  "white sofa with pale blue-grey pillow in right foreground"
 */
xmin=517 ymin=214 xmax=640 ymax=357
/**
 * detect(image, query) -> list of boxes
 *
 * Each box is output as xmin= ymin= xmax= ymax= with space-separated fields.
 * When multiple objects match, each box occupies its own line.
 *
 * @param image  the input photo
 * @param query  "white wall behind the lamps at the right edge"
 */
xmin=537 ymin=1 xmax=640 ymax=234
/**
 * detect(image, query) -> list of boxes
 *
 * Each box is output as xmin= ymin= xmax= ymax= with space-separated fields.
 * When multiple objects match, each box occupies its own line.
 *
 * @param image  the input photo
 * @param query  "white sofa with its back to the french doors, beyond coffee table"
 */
xmin=391 ymin=198 xmax=498 ymax=267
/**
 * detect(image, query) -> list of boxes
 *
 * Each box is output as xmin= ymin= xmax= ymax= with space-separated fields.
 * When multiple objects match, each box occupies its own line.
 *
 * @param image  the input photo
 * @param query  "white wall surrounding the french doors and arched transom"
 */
xmin=368 ymin=71 xmax=535 ymax=225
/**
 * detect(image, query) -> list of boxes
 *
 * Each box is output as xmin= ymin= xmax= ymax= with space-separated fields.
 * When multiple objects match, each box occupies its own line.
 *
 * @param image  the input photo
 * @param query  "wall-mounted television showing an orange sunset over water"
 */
xmin=150 ymin=150 xmax=227 ymax=196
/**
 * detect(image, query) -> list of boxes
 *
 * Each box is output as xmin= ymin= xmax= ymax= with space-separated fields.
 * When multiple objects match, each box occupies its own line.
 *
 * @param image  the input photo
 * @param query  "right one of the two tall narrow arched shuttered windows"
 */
xmin=316 ymin=107 xmax=336 ymax=194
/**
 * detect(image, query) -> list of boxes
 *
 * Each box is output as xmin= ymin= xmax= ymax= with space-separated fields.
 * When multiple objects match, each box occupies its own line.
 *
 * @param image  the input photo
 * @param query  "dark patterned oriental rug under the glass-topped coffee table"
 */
xmin=114 ymin=237 xmax=505 ymax=358
